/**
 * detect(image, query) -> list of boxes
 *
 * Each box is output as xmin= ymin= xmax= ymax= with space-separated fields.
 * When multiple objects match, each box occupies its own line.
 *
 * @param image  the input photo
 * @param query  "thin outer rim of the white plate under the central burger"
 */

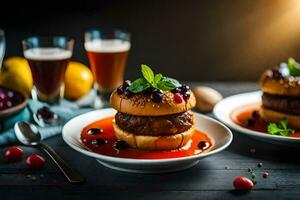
xmin=62 ymin=108 xmax=233 ymax=164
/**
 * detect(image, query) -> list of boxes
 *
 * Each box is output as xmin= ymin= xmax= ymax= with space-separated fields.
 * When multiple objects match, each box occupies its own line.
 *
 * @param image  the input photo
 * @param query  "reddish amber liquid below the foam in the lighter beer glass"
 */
xmin=87 ymin=50 xmax=128 ymax=92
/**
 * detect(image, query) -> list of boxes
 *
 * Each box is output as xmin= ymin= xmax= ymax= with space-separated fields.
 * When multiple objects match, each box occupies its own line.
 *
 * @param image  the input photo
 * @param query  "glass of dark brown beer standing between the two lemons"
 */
xmin=22 ymin=36 xmax=74 ymax=104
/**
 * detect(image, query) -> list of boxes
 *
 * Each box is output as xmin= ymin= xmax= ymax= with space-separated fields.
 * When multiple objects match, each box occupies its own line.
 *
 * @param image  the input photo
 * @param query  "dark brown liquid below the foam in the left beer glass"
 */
xmin=27 ymin=58 xmax=70 ymax=103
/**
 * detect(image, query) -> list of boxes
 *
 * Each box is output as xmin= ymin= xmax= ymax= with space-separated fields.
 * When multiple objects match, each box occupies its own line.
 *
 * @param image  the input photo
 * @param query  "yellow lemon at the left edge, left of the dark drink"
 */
xmin=0 ymin=56 xmax=33 ymax=96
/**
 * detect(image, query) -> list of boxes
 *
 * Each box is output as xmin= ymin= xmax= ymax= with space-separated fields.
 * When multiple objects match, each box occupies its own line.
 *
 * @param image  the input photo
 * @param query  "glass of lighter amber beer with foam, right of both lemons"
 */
xmin=84 ymin=29 xmax=130 ymax=107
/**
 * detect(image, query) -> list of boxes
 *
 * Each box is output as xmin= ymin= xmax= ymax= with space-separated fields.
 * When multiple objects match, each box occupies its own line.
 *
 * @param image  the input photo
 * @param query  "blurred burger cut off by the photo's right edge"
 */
xmin=260 ymin=59 xmax=300 ymax=129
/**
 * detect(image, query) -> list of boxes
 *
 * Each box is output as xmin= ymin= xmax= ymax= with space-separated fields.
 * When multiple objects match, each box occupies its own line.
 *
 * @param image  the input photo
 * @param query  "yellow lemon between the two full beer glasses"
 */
xmin=64 ymin=62 xmax=93 ymax=100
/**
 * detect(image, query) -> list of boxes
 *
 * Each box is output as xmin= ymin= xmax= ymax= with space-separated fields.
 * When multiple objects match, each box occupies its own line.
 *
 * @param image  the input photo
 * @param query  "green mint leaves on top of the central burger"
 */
xmin=128 ymin=64 xmax=181 ymax=93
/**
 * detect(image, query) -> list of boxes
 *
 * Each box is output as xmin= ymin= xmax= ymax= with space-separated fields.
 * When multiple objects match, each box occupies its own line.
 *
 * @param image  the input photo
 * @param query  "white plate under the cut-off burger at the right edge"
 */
xmin=213 ymin=91 xmax=300 ymax=146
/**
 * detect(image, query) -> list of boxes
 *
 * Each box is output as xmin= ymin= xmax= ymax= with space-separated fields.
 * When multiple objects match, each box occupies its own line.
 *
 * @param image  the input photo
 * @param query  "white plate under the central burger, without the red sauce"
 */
xmin=62 ymin=108 xmax=232 ymax=173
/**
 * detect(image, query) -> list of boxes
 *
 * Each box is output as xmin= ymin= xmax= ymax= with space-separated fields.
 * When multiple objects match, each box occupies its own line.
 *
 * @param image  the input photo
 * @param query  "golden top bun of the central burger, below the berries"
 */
xmin=110 ymin=90 xmax=196 ymax=116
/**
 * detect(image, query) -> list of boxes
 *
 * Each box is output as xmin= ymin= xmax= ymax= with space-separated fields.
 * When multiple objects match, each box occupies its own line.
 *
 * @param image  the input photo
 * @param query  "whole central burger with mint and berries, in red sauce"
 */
xmin=110 ymin=65 xmax=196 ymax=150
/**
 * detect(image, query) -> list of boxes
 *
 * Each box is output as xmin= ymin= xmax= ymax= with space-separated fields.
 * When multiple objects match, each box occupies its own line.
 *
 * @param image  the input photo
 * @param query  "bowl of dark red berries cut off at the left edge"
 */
xmin=0 ymin=86 xmax=28 ymax=119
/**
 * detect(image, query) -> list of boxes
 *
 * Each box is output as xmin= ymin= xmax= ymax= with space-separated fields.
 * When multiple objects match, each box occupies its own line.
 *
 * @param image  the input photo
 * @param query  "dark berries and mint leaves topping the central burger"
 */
xmin=117 ymin=65 xmax=191 ymax=103
